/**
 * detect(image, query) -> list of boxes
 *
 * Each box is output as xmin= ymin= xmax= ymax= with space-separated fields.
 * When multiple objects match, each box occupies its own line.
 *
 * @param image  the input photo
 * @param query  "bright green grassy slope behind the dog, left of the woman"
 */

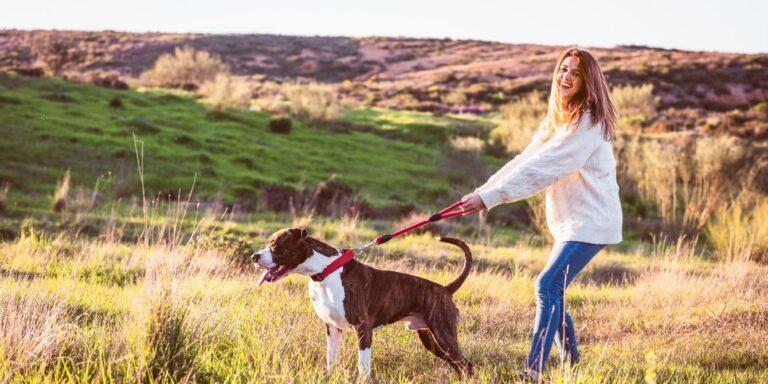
xmin=0 ymin=75 xmax=496 ymax=212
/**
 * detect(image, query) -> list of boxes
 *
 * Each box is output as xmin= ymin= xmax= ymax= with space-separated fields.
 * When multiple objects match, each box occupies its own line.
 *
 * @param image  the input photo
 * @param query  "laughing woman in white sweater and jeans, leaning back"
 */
xmin=462 ymin=48 xmax=622 ymax=380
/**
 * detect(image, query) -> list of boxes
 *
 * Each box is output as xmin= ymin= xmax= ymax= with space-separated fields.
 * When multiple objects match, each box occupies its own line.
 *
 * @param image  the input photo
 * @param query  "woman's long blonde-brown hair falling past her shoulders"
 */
xmin=541 ymin=47 xmax=619 ymax=141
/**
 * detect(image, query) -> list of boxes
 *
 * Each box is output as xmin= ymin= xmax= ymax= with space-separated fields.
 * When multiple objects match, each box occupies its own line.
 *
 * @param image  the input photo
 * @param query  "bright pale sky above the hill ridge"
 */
xmin=0 ymin=0 xmax=768 ymax=53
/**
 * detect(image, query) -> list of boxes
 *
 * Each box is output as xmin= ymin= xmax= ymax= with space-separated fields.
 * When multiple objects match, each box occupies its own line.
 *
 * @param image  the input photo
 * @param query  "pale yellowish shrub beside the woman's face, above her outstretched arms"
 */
xmin=491 ymin=91 xmax=547 ymax=152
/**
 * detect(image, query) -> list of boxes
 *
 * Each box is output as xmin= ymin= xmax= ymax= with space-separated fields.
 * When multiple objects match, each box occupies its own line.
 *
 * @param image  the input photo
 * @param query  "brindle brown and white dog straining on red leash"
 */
xmin=253 ymin=228 xmax=472 ymax=381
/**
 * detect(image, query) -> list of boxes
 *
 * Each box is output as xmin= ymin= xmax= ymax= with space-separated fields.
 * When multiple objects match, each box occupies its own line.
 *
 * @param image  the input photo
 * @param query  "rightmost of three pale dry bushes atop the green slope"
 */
xmin=282 ymin=83 xmax=342 ymax=121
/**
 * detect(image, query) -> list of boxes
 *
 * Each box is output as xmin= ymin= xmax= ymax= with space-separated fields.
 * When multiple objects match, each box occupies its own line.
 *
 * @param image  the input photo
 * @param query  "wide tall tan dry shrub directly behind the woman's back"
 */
xmin=617 ymin=136 xmax=764 ymax=234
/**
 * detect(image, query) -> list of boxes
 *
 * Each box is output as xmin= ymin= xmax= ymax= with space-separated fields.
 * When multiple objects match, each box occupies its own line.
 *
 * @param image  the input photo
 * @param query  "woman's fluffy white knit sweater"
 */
xmin=476 ymin=112 xmax=622 ymax=244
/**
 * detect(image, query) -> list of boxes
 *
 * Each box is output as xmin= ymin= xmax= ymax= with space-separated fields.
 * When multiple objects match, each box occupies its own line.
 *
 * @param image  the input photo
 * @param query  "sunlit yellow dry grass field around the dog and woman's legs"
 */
xmin=0 ymin=207 xmax=768 ymax=383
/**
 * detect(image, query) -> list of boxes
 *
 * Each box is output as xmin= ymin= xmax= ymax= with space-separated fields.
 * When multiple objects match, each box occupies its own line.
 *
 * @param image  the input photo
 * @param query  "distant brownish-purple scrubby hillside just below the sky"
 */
xmin=0 ymin=30 xmax=768 ymax=140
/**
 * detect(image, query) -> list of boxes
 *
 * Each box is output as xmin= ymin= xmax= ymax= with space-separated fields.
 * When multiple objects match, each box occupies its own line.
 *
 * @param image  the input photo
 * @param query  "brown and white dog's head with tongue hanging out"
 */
xmin=252 ymin=228 xmax=338 ymax=286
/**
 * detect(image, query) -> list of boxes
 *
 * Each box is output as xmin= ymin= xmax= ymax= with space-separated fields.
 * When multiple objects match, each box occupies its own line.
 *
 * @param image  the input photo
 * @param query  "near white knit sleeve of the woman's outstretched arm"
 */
xmin=479 ymin=115 xmax=604 ymax=210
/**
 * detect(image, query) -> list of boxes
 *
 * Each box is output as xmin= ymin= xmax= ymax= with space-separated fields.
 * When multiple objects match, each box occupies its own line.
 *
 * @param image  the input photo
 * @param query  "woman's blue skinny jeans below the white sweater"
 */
xmin=526 ymin=241 xmax=605 ymax=372
